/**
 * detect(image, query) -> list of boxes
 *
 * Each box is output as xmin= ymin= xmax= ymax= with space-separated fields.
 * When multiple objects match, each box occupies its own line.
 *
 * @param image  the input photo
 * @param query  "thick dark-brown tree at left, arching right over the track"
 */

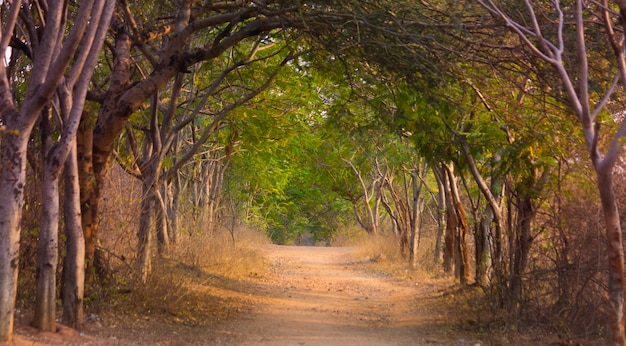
xmin=79 ymin=1 xmax=299 ymax=273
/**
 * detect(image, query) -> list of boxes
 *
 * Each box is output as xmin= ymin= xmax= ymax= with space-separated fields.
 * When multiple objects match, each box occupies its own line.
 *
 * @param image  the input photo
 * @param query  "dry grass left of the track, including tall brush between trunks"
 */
xmin=80 ymin=166 xmax=268 ymax=326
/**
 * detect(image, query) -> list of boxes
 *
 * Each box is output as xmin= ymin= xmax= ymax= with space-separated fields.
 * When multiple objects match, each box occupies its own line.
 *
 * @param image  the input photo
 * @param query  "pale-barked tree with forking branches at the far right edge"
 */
xmin=479 ymin=0 xmax=626 ymax=345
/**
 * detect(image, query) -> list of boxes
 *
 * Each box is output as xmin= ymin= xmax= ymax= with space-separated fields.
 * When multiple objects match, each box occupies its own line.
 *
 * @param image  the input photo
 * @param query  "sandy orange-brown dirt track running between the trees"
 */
xmin=210 ymin=245 xmax=458 ymax=346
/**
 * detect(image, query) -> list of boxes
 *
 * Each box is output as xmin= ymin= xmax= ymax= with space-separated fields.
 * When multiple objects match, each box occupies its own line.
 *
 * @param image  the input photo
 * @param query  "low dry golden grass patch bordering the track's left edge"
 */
xmin=98 ymin=229 xmax=268 ymax=326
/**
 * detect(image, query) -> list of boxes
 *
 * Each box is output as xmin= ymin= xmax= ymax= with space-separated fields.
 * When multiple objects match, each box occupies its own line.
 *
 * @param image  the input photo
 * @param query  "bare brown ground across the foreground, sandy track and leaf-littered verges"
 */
xmin=13 ymin=245 xmax=584 ymax=346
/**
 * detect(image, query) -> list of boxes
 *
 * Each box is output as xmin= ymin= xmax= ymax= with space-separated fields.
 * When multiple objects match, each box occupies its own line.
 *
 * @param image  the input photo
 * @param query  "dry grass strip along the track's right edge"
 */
xmin=342 ymin=230 xmax=595 ymax=345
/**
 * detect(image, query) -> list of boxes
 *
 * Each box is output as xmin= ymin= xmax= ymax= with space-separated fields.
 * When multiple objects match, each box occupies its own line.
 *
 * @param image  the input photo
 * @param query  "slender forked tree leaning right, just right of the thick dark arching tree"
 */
xmin=119 ymin=40 xmax=294 ymax=282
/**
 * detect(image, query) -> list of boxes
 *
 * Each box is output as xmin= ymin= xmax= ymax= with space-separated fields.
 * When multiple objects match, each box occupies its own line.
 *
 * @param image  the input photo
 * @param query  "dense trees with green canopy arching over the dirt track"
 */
xmin=0 ymin=0 xmax=626 ymax=345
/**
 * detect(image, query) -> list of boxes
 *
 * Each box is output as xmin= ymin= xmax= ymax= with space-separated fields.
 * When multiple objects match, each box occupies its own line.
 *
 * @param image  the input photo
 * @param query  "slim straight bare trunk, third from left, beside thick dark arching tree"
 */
xmin=61 ymin=141 xmax=85 ymax=330
